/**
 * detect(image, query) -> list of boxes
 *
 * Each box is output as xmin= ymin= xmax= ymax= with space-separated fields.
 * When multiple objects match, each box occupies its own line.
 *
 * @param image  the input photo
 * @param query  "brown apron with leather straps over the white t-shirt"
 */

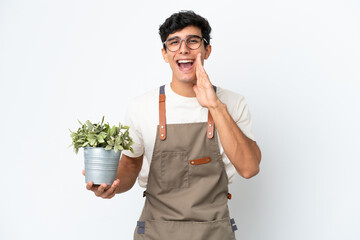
xmin=134 ymin=86 xmax=237 ymax=240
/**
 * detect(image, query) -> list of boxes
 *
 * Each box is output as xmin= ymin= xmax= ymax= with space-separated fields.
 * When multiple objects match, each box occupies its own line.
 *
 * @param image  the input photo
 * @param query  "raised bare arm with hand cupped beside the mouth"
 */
xmin=193 ymin=54 xmax=261 ymax=178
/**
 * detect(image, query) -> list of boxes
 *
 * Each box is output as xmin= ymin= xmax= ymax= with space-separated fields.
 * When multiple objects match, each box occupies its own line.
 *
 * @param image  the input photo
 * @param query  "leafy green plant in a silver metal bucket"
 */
xmin=69 ymin=117 xmax=134 ymax=185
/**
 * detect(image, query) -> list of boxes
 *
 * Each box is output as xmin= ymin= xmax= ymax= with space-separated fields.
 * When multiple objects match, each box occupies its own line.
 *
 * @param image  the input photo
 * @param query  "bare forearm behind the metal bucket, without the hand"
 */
xmin=116 ymin=155 xmax=143 ymax=193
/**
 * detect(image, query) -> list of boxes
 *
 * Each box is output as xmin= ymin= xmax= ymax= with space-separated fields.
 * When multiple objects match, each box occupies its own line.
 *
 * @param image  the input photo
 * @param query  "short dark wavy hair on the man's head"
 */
xmin=159 ymin=11 xmax=211 ymax=50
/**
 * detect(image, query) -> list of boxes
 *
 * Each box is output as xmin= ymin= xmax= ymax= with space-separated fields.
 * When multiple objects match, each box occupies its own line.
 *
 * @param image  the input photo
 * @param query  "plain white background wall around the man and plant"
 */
xmin=0 ymin=0 xmax=360 ymax=240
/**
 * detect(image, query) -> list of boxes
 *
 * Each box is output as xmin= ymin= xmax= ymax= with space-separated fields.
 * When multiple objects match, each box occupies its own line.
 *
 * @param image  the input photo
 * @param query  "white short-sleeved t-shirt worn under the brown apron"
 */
xmin=123 ymin=84 xmax=255 ymax=188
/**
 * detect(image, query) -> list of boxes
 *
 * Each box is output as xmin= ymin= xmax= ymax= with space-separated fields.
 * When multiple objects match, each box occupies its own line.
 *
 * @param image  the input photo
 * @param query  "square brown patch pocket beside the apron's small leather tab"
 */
xmin=160 ymin=152 xmax=189 ymax=189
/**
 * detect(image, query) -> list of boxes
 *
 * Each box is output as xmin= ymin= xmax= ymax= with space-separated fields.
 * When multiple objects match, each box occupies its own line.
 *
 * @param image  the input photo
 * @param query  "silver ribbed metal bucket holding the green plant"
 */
xmin=84 ymin=147 xmax=121 ymax=185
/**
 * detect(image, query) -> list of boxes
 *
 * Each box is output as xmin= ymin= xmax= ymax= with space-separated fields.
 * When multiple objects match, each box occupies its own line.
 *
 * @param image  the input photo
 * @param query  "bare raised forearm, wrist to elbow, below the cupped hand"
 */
xmin=209 ymin=100 xmax=261 ymax=178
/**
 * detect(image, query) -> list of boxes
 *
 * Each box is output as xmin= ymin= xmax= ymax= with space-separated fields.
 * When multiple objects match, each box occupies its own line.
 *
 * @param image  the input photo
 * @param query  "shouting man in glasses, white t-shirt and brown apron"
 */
xmin=86 ymin=11 xmax=261 ymax=240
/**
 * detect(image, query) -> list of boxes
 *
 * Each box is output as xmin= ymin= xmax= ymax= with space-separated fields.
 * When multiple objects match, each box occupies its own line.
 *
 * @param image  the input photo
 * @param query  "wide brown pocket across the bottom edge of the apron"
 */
xmin=135 ymin=218 xmax=235 ymax=240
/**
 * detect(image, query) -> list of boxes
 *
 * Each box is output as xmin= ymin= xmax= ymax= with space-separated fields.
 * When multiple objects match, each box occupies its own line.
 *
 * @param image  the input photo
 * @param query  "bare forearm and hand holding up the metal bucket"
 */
xmin=83 ymin=154 xmax=143 ymax=199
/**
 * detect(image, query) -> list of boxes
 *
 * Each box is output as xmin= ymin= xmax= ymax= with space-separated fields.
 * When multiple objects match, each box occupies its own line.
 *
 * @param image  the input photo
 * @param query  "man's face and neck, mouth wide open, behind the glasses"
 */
xmin=162 ymin=26 xmax=211 ymax=84
